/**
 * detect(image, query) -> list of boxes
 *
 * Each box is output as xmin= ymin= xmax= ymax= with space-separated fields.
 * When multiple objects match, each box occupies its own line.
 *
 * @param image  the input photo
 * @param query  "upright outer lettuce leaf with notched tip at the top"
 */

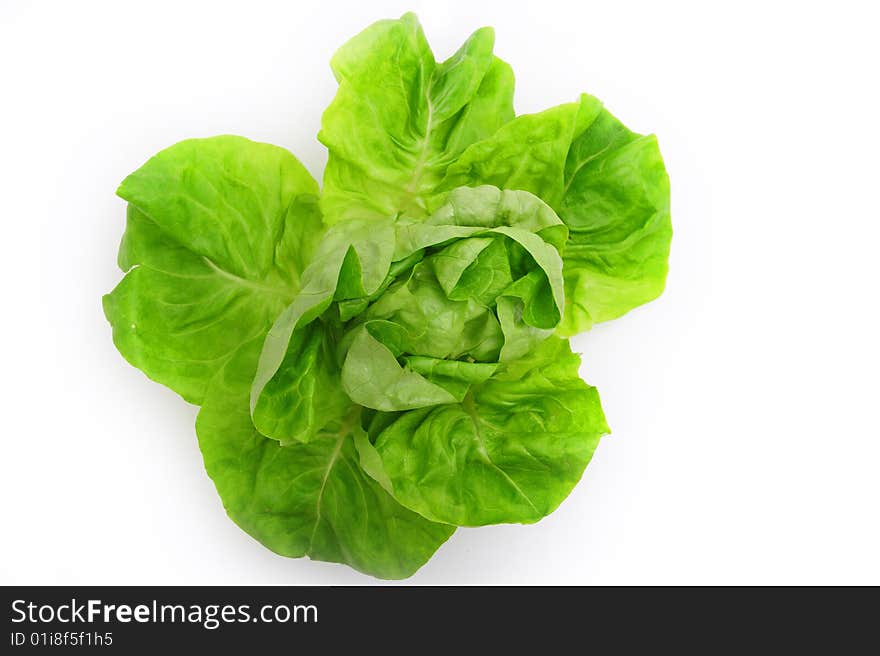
xmin=318 ymin=14 xmax=513 ymax=223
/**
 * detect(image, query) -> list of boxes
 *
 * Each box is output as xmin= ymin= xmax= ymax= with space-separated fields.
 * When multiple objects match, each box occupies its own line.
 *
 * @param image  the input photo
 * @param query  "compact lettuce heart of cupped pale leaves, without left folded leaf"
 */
xmin=342 ymin=186 xmax=565 ymax=411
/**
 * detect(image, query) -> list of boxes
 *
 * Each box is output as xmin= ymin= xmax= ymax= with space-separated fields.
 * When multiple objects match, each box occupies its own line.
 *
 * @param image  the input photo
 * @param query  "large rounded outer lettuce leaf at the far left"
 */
xmin=104 ymin=136 xmax=322 ymax=403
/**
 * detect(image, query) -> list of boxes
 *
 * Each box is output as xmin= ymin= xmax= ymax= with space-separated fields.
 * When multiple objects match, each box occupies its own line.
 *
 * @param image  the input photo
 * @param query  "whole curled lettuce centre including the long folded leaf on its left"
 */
xmin=251 ymin=186 xmax=566 ymax=436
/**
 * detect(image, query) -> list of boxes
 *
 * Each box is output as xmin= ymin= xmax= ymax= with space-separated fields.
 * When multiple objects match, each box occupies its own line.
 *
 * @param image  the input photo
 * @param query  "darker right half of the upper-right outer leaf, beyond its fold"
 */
xmin=559 ymin=110 xmax=672 ymax=335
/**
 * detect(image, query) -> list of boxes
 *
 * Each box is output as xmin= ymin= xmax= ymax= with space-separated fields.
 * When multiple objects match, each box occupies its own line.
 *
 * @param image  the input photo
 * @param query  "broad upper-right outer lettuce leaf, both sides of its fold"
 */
xmin=432 ymin=94 xmax=672 ymax=335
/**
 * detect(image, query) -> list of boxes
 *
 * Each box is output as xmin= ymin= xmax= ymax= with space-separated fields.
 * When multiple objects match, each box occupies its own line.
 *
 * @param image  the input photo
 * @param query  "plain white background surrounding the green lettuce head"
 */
xmin=0 ymin=0 xmax=880 ymax=584
